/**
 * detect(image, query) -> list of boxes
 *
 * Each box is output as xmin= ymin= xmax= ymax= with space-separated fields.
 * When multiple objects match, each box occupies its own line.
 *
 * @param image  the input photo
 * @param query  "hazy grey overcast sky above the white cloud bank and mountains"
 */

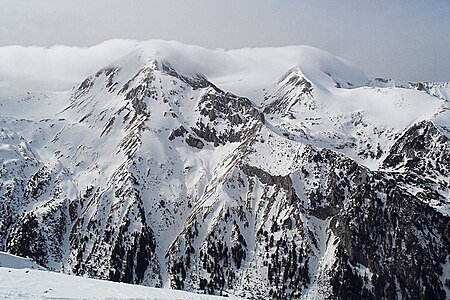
xmin=0 ymin=0 xmax=450 ymax=81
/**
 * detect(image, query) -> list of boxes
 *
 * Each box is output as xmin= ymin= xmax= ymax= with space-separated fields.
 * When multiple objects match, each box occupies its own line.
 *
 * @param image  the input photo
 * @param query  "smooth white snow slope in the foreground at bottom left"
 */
xmin=0 ymin=252 xmax=243 ymax=300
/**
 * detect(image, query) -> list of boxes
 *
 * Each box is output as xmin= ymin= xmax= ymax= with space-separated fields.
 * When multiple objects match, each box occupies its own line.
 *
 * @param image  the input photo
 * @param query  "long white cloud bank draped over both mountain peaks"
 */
xmin=0 ymin=39 xmax=368 ymax=98
